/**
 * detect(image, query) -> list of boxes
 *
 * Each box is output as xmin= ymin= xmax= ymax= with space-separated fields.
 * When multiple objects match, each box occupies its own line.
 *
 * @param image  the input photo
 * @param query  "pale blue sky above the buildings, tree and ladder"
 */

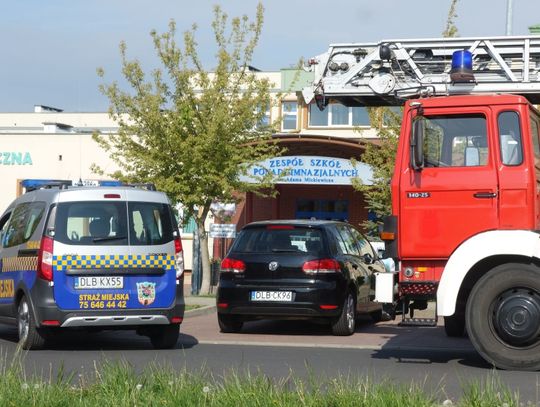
xmin=0 ymin=0 xmax=540 ymax=112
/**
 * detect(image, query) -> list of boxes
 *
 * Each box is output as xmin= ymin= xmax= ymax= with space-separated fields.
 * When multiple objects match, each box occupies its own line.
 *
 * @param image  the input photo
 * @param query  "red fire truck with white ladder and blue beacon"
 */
xmin=303 ymin=36 xmax=540 ymax=370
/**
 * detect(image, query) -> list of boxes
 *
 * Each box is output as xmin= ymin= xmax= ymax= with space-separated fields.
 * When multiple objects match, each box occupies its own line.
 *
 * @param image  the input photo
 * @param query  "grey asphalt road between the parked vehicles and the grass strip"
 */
xmin=0 ymin=314 xmax=540 ymax=405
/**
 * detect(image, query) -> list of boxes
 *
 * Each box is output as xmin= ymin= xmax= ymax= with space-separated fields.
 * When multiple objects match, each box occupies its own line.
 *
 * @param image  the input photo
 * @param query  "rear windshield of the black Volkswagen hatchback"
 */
xmin=232 ymin=226 xmax=323 ymax=253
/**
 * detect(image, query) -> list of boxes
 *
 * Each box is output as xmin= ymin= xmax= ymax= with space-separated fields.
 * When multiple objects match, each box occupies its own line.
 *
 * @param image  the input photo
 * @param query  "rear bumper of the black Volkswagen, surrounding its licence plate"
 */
xmin=217 ymin=280 xmax=345 ymax=319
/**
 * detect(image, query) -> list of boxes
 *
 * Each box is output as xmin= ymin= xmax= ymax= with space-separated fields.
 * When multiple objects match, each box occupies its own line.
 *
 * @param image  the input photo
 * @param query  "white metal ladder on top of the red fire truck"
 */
xmin=302 ymin=36 xmax=540 ymax=108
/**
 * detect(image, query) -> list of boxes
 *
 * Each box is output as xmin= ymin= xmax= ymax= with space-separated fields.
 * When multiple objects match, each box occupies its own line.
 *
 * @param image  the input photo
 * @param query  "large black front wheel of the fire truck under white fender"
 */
xmin=465 ymin=263 xmax=540 ymax=370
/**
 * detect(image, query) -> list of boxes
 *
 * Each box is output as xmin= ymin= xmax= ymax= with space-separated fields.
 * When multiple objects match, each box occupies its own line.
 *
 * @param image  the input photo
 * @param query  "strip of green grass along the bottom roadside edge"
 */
xmin=0 ymin=362 xmax=520 ymax=407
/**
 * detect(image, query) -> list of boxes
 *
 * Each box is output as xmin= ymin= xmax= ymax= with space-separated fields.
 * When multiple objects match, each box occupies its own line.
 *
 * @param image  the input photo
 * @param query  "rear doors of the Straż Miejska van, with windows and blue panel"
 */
xmin=53 ymin=194 xmax=176 ymax=311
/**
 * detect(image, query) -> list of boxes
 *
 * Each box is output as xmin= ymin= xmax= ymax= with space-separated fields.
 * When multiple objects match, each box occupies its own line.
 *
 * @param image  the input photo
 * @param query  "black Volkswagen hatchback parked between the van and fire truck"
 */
xmin=217 ymin=220 xmax=385 ymax=335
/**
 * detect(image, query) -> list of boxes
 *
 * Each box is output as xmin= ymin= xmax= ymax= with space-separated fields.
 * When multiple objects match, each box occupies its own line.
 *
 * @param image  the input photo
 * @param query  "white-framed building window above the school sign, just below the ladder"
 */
xmin=309 ymin=103 xmax=371 ymax=127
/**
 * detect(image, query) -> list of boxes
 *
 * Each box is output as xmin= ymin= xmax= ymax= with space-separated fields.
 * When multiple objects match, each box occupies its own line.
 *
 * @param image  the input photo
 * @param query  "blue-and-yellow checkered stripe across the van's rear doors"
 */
xmin=52 ymin=255 xmax=175 ymax=271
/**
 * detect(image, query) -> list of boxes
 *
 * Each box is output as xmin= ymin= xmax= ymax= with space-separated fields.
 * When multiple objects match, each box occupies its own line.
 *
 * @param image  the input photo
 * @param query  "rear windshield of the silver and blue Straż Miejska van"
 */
xmin=54 ymin=201 xmax=173 ymax=246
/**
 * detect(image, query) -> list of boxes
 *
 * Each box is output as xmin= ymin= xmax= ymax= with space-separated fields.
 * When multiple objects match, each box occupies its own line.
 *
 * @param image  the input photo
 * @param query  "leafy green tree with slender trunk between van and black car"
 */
xmin=94 ymin=4 xmax=280 ymax=294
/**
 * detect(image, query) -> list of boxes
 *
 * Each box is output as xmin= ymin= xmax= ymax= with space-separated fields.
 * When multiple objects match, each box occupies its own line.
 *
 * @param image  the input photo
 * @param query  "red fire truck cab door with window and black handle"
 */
xmin=399 ymin=108 xmax=498 ymax=259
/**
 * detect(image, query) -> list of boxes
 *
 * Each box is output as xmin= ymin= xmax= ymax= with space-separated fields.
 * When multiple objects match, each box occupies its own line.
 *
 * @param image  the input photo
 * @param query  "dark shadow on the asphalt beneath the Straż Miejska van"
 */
xmin=0 ymin=326 xmax=199 ymax=351
